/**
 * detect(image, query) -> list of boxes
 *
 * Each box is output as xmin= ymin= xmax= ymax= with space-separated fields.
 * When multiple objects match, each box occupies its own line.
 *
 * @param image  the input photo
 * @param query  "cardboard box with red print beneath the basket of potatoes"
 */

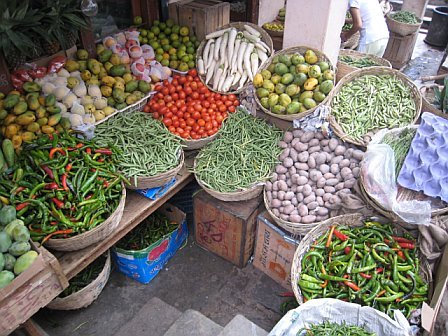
xmin=253 ymin=211 xmax=300 ymax=290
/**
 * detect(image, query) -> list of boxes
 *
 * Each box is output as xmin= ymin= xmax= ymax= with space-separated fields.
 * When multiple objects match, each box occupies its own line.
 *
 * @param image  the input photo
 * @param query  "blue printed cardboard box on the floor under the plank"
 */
xmin=112 ymin=204 xmax=188 ymax=284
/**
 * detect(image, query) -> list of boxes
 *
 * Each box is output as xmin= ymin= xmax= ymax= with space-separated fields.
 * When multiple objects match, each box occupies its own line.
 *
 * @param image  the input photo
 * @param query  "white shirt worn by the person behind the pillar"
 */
xmin=349 ymin=0 xmax=389 ymax=45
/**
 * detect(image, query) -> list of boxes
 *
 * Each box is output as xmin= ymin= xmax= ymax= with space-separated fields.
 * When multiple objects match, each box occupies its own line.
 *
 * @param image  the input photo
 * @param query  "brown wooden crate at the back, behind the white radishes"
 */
xmin=168 ymin=0 xmax=230 ymax=41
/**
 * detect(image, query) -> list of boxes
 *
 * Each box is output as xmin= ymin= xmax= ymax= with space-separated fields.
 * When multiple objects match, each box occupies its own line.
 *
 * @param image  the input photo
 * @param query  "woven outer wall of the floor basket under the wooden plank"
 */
xmin=47 ymin=251 xmax=111 ymax=310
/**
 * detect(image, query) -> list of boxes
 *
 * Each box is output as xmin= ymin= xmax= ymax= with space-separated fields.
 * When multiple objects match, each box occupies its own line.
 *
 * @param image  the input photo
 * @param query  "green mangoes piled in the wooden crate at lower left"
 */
xmin=0 ymin=203 xmax=38 ymax=289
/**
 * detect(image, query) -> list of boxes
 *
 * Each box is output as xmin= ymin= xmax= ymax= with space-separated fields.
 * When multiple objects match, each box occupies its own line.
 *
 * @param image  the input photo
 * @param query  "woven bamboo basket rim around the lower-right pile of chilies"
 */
xmin=291 ymin=214 xmax=432 ymax=305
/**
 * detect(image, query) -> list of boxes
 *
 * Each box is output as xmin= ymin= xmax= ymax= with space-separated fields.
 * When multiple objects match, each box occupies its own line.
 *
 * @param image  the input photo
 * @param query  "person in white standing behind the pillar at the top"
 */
xmin=341 ymin=0 xmax=389 ymax=57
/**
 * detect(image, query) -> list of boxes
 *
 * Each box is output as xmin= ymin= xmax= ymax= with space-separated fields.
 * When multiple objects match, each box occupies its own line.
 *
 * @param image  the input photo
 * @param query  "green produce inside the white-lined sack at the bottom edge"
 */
xmin=297 ymin=321 xmax=376 ymax=336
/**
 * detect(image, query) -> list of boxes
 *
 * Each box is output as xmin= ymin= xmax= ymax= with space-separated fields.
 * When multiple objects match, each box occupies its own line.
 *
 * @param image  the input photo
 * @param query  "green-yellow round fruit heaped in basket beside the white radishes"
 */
xmin=254 ymin=50 xmax=334 ymax=114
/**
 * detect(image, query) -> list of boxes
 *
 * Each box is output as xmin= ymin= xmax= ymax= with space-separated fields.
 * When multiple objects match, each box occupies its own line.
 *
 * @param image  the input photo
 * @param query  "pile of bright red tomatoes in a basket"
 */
xmin=143 ymin=69 xmax=240 ymax=140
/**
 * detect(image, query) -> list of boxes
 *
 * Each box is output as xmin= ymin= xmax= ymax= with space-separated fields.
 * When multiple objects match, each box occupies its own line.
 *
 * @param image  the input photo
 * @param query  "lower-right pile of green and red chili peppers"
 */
xmin=298 ymin=221 xmax=428 ymax=317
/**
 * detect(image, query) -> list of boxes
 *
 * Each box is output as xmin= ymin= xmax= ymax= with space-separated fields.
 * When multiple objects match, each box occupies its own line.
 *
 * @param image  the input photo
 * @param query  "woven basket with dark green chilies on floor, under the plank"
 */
xmin=47 ymin=251 xmax=111 ymax=310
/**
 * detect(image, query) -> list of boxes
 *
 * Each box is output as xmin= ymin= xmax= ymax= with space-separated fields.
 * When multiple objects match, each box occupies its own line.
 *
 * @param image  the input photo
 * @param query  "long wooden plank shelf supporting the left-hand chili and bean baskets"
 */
xmin=58 ymin=167 xmax=193 ymax=280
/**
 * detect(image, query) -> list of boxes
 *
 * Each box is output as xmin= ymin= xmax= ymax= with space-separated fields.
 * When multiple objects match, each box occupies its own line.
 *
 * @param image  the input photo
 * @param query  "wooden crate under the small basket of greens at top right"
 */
xmin=383 ymin=32 xmax=418 ymax=69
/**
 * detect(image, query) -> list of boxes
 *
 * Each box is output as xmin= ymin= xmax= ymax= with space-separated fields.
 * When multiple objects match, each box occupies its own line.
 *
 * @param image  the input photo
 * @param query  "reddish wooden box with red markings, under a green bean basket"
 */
xmin=193 ymin=190 xmax=262 ymax=267
